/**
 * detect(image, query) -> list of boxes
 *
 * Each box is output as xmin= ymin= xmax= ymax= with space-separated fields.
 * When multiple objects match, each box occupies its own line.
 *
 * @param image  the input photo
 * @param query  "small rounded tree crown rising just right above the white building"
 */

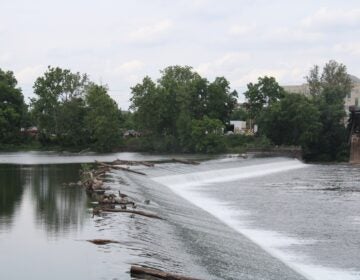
xmin=244 ymin=76 xmax=284 ymax=124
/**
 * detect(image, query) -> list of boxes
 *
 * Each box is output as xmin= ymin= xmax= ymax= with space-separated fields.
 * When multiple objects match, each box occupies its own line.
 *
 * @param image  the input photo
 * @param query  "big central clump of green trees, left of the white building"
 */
xmin=130 ymin=66 xmax=237 ymax=152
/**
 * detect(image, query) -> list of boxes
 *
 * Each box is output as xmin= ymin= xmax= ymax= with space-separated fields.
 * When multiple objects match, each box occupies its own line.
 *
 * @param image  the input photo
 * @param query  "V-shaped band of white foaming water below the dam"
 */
xmin=153 ymin=159 xmax=360 ymax=280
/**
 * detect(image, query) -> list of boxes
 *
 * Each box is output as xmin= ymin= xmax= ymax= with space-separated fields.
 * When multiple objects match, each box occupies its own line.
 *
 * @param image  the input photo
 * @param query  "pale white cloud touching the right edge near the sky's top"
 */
xmin=301 ymin=8 xmax=360 ymax=29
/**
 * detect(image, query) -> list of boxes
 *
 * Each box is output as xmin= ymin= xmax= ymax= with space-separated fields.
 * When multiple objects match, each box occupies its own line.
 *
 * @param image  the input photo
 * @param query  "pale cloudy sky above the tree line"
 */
xmin=0 ymin=0 xmax=360 ymax=110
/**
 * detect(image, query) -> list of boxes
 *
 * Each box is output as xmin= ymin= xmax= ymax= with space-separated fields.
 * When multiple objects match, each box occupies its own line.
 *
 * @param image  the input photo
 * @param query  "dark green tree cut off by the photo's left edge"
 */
xmin=0 ymin=69 xmax=27 ymax=144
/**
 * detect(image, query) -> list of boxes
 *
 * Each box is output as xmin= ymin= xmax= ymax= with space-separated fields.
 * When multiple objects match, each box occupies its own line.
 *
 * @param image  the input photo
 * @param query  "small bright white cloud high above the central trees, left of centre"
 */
xmin=128 ymin=20 xmax=173 ymax=42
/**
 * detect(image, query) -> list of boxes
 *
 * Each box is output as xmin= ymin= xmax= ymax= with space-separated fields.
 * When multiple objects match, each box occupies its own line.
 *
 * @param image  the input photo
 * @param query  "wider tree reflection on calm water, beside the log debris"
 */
xmin=29 ymin=164 xmax=87 ymax=234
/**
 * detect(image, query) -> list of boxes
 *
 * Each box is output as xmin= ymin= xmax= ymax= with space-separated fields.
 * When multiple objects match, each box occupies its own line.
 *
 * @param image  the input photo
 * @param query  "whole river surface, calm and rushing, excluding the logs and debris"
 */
xmin=0 ymin=153 xmax=360 ymax=280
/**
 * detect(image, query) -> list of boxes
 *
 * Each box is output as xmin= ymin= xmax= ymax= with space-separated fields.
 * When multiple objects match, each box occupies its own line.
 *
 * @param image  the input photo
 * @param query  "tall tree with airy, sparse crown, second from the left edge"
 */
xmin=31 ymin=66 xmax=89 ymax=138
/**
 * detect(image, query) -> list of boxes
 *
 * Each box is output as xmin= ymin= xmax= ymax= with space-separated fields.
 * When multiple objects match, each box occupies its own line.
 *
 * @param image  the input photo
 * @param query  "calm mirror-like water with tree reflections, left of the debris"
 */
xmin=0 ymin=165 xmax=100 ymax=279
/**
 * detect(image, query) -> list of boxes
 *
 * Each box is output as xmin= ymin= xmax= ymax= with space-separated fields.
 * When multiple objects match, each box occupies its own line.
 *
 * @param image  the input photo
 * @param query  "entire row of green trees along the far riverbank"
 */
xmin=0 ymin=61 xmax=352 ymax=161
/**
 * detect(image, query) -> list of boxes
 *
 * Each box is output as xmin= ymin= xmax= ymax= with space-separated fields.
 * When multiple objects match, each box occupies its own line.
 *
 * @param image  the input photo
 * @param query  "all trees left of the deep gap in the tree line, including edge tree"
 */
xmin=0 ymin=66 xmax=122 ymax=151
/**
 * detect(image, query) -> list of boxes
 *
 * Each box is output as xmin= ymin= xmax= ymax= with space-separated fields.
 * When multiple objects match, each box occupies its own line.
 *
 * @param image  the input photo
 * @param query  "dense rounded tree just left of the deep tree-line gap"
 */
xmin=85 ymin=84 xmax=122 ymax=152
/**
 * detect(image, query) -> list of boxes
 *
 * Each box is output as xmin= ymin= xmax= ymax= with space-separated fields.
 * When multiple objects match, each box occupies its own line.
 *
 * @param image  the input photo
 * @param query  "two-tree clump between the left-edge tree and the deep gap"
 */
xmin=31 ymin=66 xmax=122 ymax=152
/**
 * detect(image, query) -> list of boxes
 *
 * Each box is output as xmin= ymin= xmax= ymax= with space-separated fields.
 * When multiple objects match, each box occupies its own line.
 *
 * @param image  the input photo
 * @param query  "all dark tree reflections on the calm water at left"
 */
xmin=0 ymin=164 xmax=87 ymax=236
